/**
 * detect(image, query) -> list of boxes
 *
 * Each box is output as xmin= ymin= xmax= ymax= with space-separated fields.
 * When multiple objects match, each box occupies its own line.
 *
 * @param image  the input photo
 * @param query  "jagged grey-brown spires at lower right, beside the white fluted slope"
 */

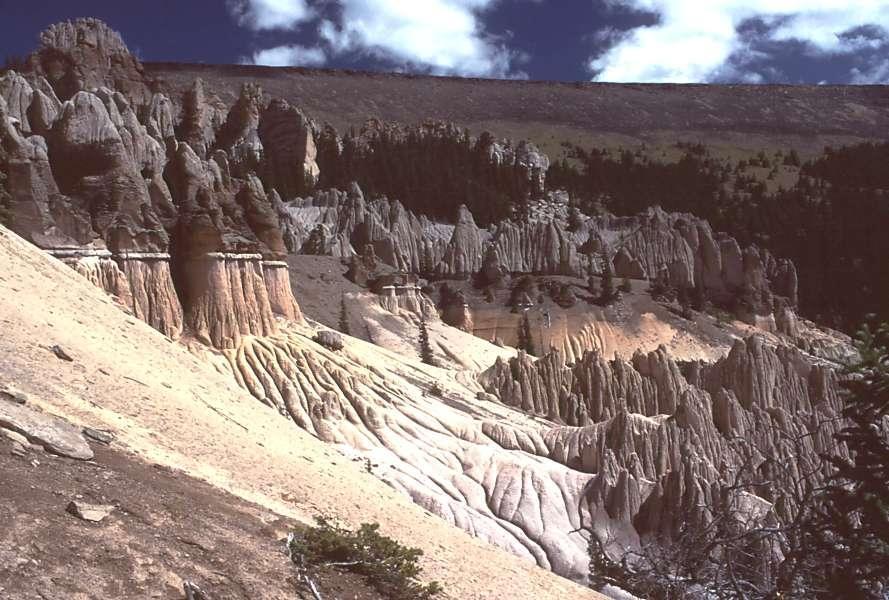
xmin=482 ymin=336 xmax=841 ymax=533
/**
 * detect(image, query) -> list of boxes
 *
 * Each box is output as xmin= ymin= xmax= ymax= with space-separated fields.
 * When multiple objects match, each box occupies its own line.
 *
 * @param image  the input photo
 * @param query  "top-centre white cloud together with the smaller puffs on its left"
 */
xmin=229 ymin=0 xmax=523 ymax=77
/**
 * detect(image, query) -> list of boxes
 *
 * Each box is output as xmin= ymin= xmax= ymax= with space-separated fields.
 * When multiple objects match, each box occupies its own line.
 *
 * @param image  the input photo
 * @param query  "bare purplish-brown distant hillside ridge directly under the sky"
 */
xmin=145 ymin=63 xmax=889 ymax=153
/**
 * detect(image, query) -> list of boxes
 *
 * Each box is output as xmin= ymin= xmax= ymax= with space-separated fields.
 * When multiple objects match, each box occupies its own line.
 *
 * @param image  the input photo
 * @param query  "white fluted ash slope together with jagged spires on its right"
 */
xmin=215 ymin=324 xmax=839 ymax=578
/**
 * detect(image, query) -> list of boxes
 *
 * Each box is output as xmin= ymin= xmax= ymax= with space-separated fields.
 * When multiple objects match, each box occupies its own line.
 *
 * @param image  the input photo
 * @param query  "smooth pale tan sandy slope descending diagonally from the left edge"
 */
xmin=0 ymin=227 xmax=599 ymax=599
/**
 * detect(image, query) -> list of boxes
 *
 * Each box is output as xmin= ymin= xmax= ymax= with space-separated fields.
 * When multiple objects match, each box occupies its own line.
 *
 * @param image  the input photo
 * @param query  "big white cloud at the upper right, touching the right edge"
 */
xmin=588 ymin=0 xmax=889 ymax=83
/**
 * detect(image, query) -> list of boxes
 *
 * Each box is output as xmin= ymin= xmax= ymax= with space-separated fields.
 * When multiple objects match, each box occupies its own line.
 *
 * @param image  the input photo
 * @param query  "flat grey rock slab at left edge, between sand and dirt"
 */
xmin=0 ymin=402 xmax=93 ymax=460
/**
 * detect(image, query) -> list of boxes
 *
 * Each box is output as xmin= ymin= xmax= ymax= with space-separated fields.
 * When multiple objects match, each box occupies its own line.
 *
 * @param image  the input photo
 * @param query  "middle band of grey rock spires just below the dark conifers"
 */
xmin=281 ymin=186 xmax=797 ymax=324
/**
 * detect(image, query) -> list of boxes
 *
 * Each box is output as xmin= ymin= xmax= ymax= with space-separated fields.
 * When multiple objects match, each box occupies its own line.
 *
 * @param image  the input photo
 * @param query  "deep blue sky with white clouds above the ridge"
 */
xmin=0 ymin=0 xmax=889 ymax=84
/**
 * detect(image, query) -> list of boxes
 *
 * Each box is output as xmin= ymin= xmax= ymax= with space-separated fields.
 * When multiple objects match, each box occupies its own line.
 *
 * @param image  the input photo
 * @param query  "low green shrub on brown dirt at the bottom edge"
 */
xmin=288 ymin=517 xmax=442 ymax=600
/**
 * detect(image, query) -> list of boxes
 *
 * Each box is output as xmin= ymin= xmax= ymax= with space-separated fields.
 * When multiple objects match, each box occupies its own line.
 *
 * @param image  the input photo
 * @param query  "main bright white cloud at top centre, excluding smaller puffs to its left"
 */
xmin=319 ymin=0 xmax=517 ymax=77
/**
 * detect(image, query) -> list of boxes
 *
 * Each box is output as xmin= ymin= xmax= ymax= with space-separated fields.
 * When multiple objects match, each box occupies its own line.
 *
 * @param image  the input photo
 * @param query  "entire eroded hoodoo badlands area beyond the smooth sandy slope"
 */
xmin=0 ymin=19 xmax=860 ymax=596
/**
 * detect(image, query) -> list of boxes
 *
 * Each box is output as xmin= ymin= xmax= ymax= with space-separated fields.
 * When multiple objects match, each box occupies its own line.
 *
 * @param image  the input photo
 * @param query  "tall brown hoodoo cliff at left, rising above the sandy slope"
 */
xmin=0 ymin=19 xmax=308 ymax=347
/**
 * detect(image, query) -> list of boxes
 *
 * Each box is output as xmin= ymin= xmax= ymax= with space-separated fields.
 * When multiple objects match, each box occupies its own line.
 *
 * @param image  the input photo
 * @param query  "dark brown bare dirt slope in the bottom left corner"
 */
xmin=0 ymin=436 xmax=383 ymax=600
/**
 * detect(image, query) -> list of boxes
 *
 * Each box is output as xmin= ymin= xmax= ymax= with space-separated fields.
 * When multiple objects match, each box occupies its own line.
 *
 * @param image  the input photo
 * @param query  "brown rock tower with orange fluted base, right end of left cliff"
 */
xmin=166 ymin=143 xmax=299 ymax=348
